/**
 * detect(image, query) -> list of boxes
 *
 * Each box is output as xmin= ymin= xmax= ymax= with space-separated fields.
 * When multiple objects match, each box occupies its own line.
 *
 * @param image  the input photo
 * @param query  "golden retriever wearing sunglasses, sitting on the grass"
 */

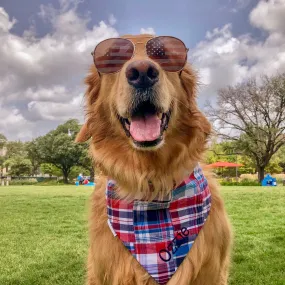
xmin=77 ymin=35 xmax=231 ymax=285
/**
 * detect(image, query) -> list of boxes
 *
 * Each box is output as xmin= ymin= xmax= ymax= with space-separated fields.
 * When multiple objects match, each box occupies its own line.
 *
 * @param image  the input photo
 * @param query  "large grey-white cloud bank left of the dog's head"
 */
xmin=0 ymin=0 xmax=118 ymax=139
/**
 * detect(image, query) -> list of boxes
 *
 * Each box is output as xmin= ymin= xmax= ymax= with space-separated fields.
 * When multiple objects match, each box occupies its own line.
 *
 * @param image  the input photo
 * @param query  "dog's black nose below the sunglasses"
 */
xmin=126 ymin=60 xmax=159 ymax=88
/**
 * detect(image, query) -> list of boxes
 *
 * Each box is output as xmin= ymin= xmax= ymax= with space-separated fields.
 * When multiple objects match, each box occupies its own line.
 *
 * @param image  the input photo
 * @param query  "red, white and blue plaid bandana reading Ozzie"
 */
xmin=106 ymin=167 xmax=211 ymax=284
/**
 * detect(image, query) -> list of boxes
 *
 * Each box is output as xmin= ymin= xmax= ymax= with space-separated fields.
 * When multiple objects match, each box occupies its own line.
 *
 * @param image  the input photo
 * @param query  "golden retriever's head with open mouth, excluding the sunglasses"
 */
xmin=77 ymin=35 xmax=210 ymax=196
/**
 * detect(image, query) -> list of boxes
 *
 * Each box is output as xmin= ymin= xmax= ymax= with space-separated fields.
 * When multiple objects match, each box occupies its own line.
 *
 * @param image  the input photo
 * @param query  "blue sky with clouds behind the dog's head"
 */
xmin=0 ymin=0 xmax=285 ymax=141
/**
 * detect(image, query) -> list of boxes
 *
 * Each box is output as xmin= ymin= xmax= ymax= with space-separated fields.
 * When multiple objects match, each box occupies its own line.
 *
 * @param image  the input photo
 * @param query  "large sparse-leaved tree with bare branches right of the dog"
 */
xmin=207 ymin=73 xmax=285 ymax=182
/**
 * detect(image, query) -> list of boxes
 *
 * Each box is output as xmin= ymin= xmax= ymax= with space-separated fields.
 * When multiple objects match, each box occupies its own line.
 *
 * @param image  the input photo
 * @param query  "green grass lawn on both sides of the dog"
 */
xmin=0 ymin=186 xmax=285 ymax=285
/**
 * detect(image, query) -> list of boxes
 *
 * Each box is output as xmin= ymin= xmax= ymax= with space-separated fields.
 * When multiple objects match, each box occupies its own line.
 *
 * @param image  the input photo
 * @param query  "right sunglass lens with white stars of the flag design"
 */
xmin=146 ymin=37 xmax=187 ymax=72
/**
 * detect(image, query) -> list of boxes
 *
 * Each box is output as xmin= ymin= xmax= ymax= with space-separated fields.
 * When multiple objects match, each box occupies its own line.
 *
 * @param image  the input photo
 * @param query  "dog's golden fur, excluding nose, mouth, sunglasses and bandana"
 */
xmin=77 ymin=35 xmax=231 ymax=285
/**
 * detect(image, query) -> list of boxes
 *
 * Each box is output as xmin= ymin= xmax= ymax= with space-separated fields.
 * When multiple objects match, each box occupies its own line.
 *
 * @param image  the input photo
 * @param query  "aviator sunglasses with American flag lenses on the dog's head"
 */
xmin=91 ymin=36 xmax=189 ymax=74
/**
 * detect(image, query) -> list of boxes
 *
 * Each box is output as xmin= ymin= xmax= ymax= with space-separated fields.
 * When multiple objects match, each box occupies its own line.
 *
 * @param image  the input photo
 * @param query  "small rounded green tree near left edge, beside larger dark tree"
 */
xmin=4 ymin=156 xmax=32 ymax=177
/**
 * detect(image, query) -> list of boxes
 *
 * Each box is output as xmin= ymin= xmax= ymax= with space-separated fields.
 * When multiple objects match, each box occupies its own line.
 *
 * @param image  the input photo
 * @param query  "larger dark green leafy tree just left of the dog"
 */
xmin=36 ymin=120 xmax=86 ymax=183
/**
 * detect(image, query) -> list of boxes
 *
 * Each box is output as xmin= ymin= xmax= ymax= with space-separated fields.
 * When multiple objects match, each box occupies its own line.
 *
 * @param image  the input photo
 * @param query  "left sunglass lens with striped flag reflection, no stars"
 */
xmin=94 ymin=39 xmax=134 ymax=73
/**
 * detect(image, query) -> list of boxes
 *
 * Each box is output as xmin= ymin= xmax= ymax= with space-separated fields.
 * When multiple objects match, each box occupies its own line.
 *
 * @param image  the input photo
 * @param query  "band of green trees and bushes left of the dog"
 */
xmin=0 ymin=119 xmax=94 ymax=183
